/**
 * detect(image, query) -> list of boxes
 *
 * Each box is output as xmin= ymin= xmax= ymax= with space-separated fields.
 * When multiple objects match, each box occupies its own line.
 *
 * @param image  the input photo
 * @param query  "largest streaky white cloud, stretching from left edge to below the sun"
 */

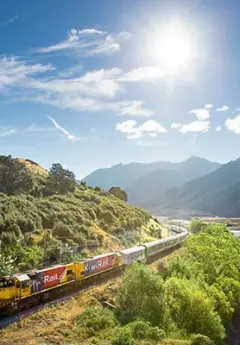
xmin=0 ymin=57 xmax=158 ymax=117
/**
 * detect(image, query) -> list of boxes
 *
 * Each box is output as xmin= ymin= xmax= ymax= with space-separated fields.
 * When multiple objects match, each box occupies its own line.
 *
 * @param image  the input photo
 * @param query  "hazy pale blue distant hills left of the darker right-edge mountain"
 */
xmin=84 ymin=156 xmax=221 ymax=207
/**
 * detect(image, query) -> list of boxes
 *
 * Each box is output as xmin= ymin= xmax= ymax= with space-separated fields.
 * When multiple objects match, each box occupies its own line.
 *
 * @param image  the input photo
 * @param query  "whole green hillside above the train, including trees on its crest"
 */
xmin=0 ymin=156 xmax=162 ymax=270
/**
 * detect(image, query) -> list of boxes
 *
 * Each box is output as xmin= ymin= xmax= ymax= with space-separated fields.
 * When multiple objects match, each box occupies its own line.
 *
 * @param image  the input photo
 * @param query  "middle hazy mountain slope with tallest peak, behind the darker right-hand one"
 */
xmin=126 ymin=156 xmax=220 ymax=208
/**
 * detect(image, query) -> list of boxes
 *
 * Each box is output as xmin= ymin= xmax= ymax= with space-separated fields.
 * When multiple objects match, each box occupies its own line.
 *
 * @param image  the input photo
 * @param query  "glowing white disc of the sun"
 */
xmin=152 ymin=28 xmax=193 ymax=70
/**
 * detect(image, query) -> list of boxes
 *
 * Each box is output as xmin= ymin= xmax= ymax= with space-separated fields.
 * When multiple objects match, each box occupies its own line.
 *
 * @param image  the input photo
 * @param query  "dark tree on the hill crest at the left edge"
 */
xmin=0 ymin=156 xmax=33 ymax=195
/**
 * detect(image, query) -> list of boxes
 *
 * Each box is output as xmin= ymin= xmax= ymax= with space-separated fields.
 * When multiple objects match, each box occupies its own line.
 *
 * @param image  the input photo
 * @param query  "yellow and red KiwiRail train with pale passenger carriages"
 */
xmin=0 ymin=231 xmax=188 ymax=316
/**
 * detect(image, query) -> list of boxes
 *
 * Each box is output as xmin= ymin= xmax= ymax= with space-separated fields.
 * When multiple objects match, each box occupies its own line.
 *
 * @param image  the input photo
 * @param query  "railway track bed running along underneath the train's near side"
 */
xmin=0 ymin=245 xmax=180 ymax=329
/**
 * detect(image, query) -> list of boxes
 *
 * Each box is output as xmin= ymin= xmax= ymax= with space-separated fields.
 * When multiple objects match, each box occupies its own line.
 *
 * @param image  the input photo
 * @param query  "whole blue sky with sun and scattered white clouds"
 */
xmin=0 ymin=0 xmax=240 ymax=178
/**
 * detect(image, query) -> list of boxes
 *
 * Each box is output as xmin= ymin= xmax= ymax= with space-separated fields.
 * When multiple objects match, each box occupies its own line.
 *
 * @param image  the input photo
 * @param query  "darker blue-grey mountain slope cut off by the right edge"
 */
xmin=158 ymin=158 xmax=240 ymax=217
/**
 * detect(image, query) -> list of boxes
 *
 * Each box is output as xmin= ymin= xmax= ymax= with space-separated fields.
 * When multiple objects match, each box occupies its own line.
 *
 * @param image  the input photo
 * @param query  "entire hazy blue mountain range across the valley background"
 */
xmin=84 ymin=156 xmax=240 ymax=216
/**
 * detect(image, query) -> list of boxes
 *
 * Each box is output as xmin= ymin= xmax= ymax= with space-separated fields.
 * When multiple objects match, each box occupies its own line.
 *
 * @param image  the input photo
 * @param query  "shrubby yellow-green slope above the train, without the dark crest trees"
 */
xmin=0 ymin=159 xmax=164 ymax=266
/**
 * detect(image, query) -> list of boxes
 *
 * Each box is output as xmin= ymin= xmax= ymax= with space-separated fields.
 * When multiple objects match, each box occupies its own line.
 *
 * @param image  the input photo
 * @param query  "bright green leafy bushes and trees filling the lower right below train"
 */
xmin=59 ymin=220 xmax=240 ymax=345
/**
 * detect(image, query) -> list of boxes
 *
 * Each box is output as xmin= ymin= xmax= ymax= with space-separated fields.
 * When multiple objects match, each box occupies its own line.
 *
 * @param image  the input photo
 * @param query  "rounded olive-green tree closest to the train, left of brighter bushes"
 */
xmin=117 ymin=263 xmax=163 ymax=326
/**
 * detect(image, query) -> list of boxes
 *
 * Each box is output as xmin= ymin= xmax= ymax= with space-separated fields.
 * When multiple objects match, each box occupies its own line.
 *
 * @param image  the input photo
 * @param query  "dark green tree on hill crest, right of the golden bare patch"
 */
xmin=46 ymin=163 xmax=76 ymax=194
